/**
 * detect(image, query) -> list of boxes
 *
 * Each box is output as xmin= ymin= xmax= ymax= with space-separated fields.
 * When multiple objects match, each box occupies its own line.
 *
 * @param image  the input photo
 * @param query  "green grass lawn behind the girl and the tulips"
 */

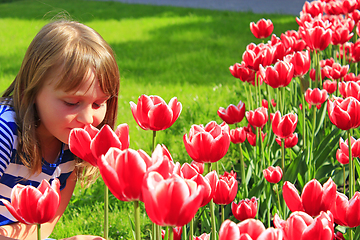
xmin=0 ymin=0 xmax=297 ymax=239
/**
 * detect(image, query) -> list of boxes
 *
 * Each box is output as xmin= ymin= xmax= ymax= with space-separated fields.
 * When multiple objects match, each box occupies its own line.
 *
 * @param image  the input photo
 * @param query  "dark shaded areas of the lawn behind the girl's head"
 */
xmin=0 ymin=1 xmax=297 ymax=85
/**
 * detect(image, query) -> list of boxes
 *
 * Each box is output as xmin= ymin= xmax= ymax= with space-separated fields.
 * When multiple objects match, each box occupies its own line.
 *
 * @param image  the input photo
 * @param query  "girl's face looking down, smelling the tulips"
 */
xmin=35 ymin=71 xmax=109 ymax=143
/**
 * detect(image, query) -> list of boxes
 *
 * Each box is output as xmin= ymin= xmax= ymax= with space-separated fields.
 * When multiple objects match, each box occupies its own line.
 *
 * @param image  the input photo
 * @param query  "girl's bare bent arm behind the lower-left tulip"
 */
xmin=0 ymin=171 xmax=103 ymax=240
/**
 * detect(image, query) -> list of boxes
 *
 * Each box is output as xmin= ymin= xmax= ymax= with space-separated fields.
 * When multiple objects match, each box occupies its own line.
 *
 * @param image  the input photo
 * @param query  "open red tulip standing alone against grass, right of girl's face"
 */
xmin=130 ymin=95 xmax=182 ymax=131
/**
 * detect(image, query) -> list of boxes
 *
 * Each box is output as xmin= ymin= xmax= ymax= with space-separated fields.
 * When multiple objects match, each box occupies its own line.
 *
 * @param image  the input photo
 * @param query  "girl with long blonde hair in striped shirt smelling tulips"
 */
xmin=0 ymin=21 xmax=120 ymax=240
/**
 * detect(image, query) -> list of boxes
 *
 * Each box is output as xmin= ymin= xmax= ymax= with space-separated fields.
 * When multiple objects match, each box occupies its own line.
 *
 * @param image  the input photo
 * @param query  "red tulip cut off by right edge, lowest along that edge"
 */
xmin=331 ymin=192 xmax=360 ymax=228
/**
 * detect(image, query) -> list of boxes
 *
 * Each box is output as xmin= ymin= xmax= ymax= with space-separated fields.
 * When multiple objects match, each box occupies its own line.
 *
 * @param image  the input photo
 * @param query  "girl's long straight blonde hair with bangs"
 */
xmin=3 ymin=20 xmax=120 ymax=182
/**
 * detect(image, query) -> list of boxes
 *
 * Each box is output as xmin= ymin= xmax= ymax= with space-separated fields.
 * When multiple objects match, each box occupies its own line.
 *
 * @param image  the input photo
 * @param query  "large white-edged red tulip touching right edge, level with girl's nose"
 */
xmin=327 ymin=97 xmax=360 ymax=130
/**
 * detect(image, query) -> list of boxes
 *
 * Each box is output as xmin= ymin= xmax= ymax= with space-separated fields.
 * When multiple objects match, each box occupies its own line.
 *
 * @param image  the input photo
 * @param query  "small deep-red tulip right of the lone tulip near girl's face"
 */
xmin=217 ymin=101 xmax=245 ymax=124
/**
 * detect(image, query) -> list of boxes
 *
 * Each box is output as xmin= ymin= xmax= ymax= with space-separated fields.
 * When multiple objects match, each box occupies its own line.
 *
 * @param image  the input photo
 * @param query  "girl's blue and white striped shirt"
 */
xmin=0 ymin=105 xmax=75 ymax=226
